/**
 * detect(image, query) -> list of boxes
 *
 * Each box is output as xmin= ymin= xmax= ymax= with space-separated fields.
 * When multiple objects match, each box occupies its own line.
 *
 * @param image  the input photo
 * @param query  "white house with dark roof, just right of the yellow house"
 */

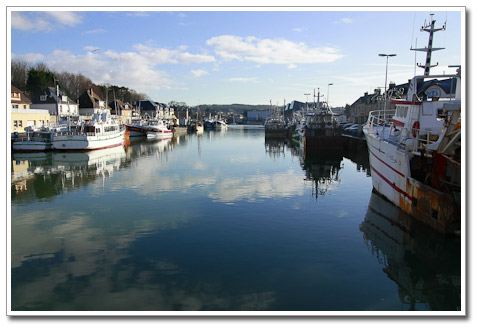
xmin=30 ymin=86 xmax=79 ymax=121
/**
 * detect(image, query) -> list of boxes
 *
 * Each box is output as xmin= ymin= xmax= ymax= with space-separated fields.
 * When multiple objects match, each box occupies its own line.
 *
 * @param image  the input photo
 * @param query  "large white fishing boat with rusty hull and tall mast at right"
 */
xmin=363 ymin=16 xmax=461 ymax=234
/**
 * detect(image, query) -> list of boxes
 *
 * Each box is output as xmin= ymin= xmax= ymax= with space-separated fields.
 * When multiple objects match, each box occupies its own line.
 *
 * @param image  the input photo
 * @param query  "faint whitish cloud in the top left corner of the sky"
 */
xmin=12 ymin=11 xmax=82 ymax=32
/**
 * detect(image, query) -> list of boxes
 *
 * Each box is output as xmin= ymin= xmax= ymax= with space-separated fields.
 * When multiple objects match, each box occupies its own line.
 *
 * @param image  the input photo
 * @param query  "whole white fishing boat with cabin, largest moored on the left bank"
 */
xmin=52 ymin=112 xmax=125 ymax=150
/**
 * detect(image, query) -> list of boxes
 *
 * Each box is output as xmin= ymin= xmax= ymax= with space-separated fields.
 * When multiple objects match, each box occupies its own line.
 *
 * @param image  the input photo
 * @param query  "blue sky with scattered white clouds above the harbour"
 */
xmin=9 ymin=7 xmax=465 ymax=106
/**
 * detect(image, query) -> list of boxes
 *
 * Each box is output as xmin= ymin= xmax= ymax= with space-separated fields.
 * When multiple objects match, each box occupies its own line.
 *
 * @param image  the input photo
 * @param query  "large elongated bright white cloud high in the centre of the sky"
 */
xmin=207 ymin=35 xmax=343 ymax=65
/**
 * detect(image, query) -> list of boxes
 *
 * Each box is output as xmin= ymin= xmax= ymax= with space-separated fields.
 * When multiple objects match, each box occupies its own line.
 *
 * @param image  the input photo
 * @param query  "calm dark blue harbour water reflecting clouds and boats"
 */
xmin=11 ymin=126 xmax=461 ymax=311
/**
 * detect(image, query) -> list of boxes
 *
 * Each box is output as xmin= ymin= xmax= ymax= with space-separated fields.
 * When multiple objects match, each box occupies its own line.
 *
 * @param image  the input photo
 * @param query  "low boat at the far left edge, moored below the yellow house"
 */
xmin=12 ymin=125 xmax=68 ymax=152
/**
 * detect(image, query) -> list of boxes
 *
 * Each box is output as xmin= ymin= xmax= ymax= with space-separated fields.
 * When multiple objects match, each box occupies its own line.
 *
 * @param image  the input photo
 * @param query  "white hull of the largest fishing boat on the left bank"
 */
xmin=52 ymin=130 xmax=124 ymax=150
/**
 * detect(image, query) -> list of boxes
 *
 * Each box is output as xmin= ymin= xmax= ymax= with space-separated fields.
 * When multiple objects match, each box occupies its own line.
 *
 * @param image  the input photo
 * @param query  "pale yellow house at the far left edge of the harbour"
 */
xmin=10 ymin=85 xmax=51 ymax=133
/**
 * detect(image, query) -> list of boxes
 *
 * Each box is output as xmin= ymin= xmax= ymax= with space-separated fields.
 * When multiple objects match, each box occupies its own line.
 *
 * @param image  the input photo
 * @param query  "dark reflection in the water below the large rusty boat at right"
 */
xmin=360 ymin=192 xmax=461 ymax=311
